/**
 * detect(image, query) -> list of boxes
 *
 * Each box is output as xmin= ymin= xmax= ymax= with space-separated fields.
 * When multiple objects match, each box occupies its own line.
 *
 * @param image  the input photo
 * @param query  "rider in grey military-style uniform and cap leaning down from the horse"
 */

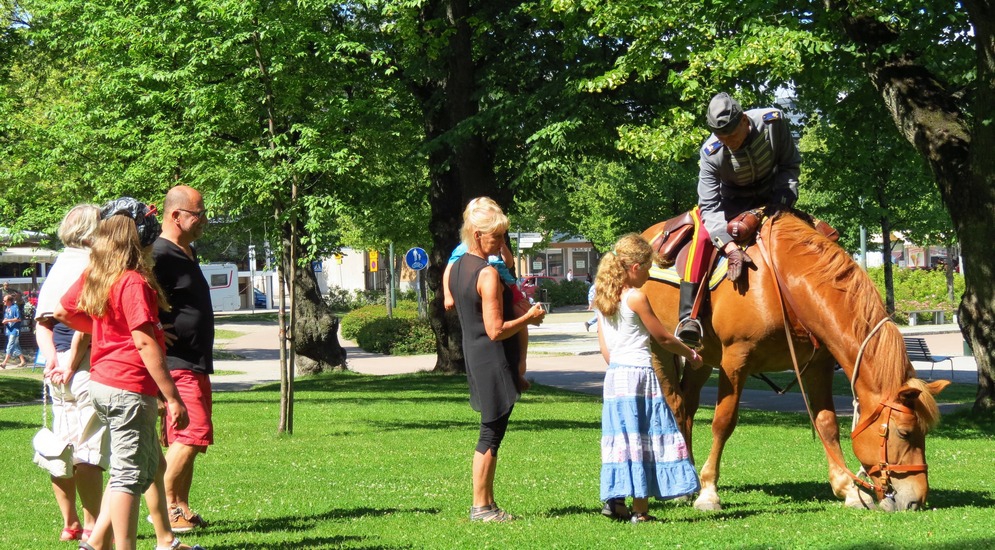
xmin=678 ymin=92 xmax=801 ymax=346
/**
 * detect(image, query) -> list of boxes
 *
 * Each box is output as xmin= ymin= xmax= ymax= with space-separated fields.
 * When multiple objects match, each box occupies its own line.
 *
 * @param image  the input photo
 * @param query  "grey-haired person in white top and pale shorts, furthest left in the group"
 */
xmin=35 ymin=204 xmax=110 ymax=542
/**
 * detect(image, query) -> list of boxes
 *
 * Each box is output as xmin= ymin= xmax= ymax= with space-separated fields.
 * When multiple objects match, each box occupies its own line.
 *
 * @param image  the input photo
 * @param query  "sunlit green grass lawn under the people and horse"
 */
xmin=0 ymin=373 xmax=995 ymax=550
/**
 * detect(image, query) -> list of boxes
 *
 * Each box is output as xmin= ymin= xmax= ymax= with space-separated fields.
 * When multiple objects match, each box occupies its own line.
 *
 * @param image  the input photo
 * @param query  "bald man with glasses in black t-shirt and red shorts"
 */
xmin=152 ymin=185 xmax=214 ymax=533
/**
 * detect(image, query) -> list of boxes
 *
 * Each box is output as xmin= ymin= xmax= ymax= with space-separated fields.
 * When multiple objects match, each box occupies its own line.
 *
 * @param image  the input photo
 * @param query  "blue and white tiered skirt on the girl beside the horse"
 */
xmin=601 ymin=363 xmax=700 ymax=501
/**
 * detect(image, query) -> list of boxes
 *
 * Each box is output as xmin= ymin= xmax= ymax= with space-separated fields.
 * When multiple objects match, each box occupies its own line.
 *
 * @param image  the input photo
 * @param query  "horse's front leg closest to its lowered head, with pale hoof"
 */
xmin=805 ymin=357 xmax=868 ymax=508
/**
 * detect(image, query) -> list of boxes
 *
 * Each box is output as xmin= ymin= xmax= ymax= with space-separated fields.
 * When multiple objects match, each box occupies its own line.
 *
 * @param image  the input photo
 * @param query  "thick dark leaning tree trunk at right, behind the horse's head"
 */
xmin=826 ymin=0 xmax=995 ymax=413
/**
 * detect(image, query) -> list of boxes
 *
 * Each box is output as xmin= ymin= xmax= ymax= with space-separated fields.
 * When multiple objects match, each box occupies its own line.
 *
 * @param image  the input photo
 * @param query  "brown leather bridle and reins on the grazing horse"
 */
xmin=757 ymin=218 xmax=927 ymax=501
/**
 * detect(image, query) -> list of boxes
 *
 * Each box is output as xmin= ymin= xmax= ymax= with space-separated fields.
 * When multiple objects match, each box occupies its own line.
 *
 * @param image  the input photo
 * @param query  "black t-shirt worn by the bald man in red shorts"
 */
xmin=152 ymin=237 xmax=214 ymax=374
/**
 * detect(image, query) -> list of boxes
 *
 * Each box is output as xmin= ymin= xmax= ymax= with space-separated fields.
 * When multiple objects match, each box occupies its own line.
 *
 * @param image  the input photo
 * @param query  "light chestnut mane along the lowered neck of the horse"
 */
xmin=773 ymin=214 xmax=920 ymax=396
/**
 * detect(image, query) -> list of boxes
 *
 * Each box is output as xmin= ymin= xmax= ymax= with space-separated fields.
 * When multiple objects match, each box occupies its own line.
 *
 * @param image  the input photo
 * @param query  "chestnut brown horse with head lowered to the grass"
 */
xmin=643 ymin=214 xmax=949 ymax=510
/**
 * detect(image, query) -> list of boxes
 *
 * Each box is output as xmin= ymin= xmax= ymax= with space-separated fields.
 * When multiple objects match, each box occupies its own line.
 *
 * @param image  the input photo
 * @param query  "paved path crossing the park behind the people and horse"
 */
xmin=212 ymin=308 xmax=977 ymax=415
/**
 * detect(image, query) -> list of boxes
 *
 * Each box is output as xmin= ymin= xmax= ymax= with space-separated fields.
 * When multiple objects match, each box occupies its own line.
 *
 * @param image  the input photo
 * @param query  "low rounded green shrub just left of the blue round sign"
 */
xmin=341 ymin=301 xmax=435 ymax=355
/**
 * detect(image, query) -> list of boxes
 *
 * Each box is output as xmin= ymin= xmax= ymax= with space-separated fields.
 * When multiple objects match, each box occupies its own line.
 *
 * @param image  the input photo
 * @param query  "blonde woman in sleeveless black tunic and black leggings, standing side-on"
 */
xmin=449 ymin=197 xmax=546 ymax=521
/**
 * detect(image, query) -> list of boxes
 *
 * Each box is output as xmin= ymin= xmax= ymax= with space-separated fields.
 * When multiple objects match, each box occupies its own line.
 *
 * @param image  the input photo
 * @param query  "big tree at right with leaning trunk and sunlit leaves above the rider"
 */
xmin=555 ymin=0 xmax=995 ymax=411
